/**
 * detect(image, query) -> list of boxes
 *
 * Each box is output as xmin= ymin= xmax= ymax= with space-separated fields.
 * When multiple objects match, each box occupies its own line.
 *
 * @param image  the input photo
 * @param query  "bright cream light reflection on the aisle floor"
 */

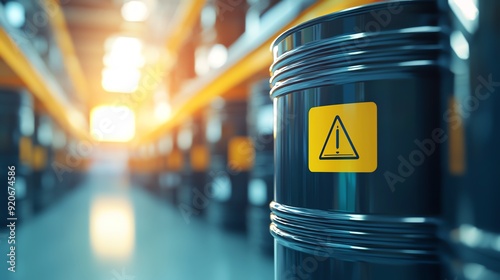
xmin=90 ymin=198 xmax=135 ymax=260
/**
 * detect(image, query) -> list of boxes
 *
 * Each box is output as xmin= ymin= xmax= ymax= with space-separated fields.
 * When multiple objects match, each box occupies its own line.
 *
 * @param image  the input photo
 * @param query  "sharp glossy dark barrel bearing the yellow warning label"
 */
xmin=271 ymin=1 xmax=450 ymax=280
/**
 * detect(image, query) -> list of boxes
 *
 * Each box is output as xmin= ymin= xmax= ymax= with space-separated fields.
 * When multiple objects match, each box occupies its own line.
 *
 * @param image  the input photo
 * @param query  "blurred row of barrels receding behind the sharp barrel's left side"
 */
xmin=129 ymin=79 xmax=274 ymax=253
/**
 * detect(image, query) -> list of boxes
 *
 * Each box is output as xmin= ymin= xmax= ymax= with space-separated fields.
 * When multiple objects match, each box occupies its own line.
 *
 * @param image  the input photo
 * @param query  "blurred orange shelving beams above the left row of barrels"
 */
xmin=0 ymin=0 xmax=89 ymax=139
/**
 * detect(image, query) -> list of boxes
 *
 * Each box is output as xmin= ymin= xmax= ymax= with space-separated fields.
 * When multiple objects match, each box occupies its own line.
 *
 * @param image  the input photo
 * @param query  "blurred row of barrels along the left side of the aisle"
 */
xmin=0 ymin=88 xmax=86 ymax=230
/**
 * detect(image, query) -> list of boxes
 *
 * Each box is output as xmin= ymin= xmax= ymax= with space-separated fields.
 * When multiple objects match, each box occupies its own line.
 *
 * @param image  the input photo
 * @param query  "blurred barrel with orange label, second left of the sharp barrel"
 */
xmin=206 ymin=99 xmax=253 ymax=230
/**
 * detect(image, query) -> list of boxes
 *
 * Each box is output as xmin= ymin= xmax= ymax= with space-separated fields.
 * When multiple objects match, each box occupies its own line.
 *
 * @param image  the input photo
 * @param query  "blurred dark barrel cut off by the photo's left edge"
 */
xmin=0 ymin=88 xmax=34 ymax=226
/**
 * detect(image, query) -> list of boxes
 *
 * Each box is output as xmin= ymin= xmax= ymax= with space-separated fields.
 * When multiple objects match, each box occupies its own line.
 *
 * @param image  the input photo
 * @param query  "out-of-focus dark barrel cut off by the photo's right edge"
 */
xmin=442 ymin=0 xmax=500 ymax=280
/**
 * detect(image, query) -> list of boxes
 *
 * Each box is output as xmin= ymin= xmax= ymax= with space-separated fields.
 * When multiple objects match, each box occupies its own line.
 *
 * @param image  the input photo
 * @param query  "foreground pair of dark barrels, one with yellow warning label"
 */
xmin=270 ymin=0 xmax=500 ymax=280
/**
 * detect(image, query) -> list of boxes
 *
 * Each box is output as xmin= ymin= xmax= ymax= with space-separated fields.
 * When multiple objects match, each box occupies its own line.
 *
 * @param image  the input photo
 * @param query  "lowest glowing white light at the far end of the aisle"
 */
xmin=90 ymin=106 xmax=135 ymax=142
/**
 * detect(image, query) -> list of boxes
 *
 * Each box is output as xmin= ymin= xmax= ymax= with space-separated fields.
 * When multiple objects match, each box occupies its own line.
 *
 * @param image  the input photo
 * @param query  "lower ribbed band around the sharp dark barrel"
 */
xmin=270 ymin=202 xmax=439 ymax=264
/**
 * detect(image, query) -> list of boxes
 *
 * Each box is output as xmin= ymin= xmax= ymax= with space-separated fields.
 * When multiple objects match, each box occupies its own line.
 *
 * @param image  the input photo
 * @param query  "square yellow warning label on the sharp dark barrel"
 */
xmin=309 ymin=102 xmax=377 ymax=172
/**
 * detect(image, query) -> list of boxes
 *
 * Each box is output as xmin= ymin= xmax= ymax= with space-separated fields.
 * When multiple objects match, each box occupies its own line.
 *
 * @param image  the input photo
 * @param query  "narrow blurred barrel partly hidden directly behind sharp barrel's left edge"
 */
xmin=247 ymin=79 xmax=274 ymax=253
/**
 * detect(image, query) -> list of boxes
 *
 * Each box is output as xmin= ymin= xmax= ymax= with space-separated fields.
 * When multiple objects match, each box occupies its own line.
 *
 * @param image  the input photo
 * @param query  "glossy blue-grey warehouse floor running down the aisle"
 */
xmin=0 ymin=160 xmax=273 ymax=280
